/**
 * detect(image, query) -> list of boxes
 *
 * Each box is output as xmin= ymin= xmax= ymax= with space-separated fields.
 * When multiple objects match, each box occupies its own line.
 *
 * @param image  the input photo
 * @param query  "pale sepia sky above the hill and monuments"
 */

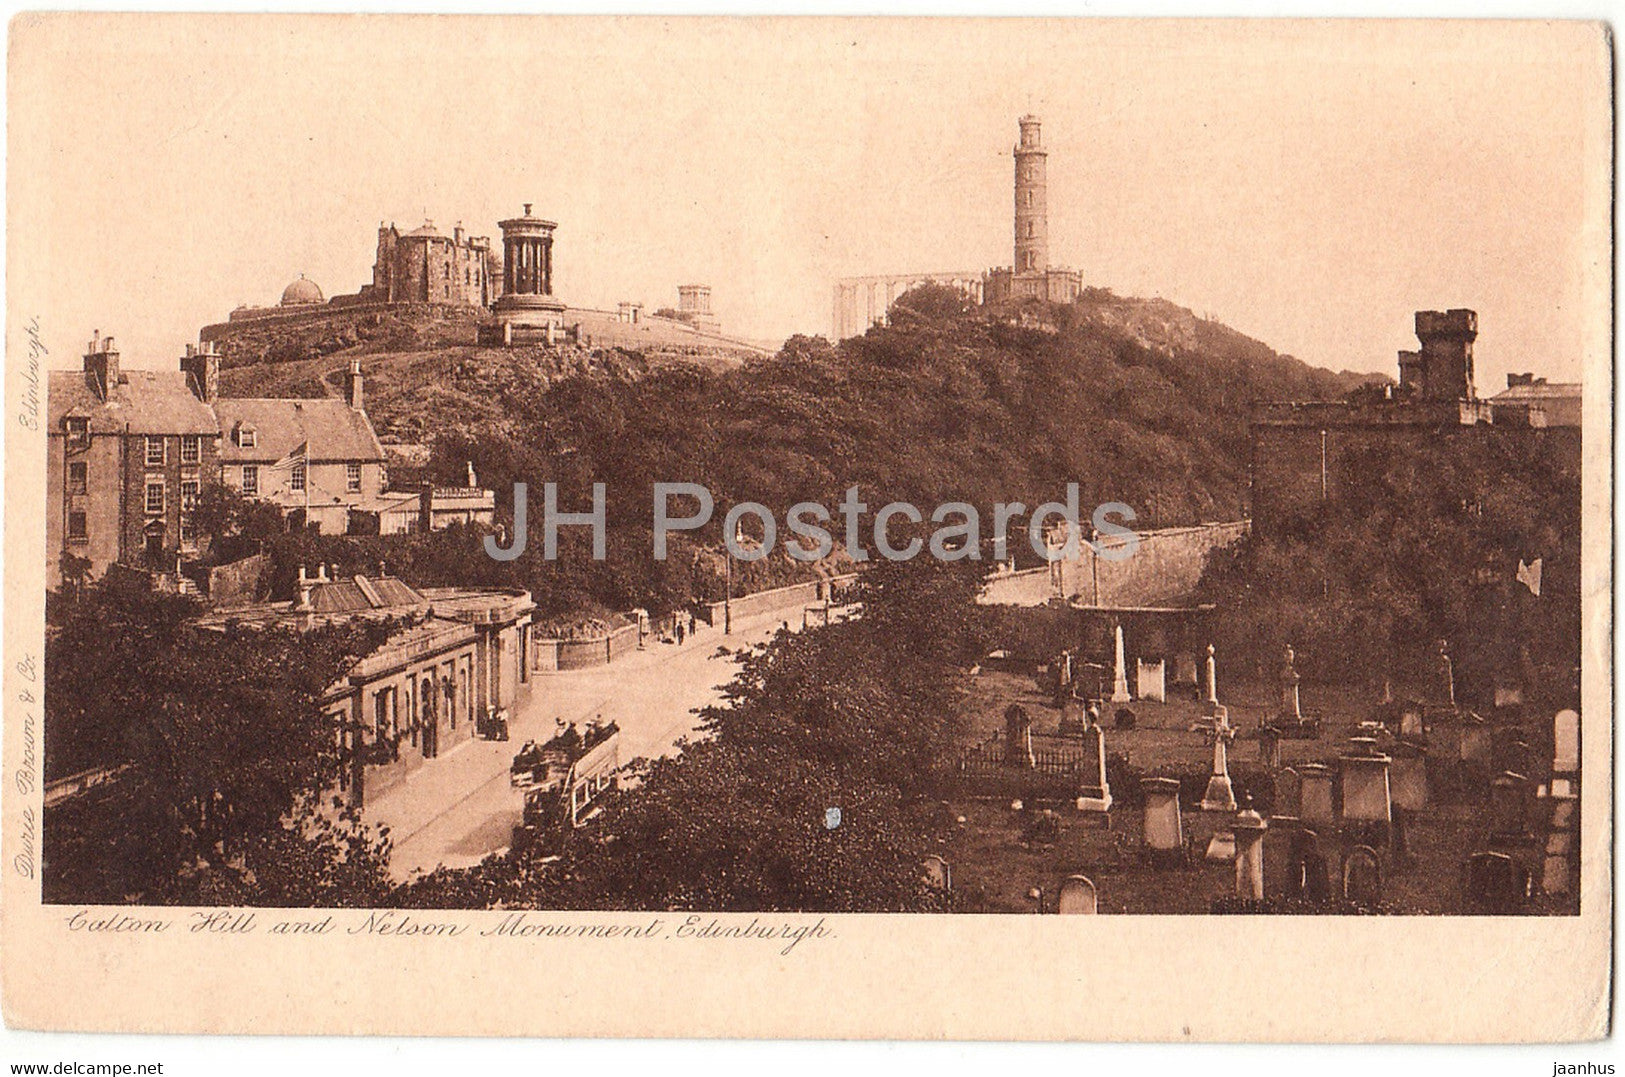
xmin=8 ymin=15 xmax=1610 ymax=393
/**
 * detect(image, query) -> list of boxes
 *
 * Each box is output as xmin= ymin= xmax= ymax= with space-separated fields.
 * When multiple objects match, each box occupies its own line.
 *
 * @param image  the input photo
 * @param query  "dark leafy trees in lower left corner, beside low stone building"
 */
xmin=46 ymin=582 xmax=392 ymax=903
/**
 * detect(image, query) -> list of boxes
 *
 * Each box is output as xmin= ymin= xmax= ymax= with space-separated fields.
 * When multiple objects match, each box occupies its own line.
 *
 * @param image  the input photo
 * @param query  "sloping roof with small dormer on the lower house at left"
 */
xmin=215 ymin=396 xmax=384 ymax=463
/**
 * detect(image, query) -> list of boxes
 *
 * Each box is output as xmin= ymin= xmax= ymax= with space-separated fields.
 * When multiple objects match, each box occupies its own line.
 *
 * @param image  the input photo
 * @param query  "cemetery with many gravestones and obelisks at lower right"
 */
xmin=923 ymin=634 xmax=1580 ymax=915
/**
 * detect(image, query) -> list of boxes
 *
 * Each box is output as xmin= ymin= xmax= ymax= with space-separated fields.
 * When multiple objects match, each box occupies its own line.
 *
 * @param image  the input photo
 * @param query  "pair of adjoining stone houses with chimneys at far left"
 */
xmin=46 ymin=333 xmax=385 ymax=588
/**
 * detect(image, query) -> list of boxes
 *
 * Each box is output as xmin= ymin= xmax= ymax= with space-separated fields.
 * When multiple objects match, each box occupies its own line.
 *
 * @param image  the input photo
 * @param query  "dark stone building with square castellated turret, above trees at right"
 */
xmin=1251 ymin=310 xmax=1580 ymax=534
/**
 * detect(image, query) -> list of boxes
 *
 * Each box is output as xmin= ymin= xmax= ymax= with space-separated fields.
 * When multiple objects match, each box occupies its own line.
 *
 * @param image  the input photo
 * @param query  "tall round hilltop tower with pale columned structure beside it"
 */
xmin=834 ymin=114 xmax=1082 ymax=340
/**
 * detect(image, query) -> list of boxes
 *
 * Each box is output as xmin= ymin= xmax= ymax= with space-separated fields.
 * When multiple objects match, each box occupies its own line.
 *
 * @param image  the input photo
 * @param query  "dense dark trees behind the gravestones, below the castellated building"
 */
xmin=1201 ymin=427 xmax=1580 ymax=703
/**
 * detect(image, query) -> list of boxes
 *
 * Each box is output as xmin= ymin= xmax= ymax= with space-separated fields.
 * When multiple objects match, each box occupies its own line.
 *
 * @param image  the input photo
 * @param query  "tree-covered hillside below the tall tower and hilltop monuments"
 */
xmin=226 ymin=288 xmax=1370 ymax=523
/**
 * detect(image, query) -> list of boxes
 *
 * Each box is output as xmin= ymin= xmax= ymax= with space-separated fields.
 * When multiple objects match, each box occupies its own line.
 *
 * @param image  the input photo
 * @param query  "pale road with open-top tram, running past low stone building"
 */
xmin=364 ymin=608 xmax=801 ymax=880
